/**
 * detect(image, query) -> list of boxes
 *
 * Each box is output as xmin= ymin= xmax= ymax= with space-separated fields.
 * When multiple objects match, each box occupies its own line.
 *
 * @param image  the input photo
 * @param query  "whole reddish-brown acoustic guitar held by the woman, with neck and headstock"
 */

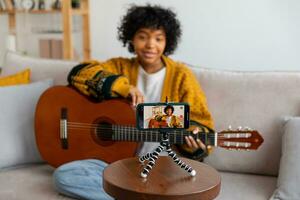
xmin=35 ymin=86 xmax=263 ymax=167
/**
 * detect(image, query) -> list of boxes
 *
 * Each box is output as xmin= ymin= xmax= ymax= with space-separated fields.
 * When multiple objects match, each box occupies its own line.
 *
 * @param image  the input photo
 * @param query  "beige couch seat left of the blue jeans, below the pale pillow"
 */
xmin=0 ymin=164 xmax=70 ymax=200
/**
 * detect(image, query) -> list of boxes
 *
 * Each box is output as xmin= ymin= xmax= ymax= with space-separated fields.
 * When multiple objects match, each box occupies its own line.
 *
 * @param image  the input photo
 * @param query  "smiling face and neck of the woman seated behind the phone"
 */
xmin=132 ymin=28 xmax=166 ymax=73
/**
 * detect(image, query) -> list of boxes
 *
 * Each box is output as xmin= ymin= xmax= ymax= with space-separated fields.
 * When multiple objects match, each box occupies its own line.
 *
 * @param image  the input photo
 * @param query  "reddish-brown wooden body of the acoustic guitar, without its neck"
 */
xmin=35 ymin=86 xmax=138 ymax=167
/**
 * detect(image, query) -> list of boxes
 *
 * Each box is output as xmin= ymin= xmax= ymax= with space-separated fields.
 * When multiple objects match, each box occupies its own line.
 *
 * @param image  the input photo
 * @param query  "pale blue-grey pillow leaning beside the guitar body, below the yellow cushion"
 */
xmin=0 ymin=80 xmax=53 ymax=169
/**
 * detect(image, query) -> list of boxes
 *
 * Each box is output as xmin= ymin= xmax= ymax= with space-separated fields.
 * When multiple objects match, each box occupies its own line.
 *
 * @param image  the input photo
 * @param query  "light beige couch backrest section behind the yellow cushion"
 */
xmin=1 ymin=51 xmax=77 ymax=85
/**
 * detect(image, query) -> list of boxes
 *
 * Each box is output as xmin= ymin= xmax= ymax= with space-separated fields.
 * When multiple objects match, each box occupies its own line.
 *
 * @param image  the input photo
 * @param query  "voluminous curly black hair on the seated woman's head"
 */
xmin=118 ymin=4 xmax=181 ymax=55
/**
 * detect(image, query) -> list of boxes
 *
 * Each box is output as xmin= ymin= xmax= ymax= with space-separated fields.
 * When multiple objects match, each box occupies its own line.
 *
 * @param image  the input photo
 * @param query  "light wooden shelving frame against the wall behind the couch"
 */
xmin=0 ymin=0 xmax=90 ymax=60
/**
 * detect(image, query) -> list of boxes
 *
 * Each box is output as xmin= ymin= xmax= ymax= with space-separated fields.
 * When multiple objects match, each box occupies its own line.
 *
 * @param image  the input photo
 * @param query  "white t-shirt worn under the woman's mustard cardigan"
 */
xmin=137 ymin=66 xmax=166 ymax=156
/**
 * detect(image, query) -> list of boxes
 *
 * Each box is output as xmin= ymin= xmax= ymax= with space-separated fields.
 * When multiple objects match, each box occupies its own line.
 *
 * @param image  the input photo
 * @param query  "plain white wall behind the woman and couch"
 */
xmin=91 ymin=0 xmax=300 ymax=70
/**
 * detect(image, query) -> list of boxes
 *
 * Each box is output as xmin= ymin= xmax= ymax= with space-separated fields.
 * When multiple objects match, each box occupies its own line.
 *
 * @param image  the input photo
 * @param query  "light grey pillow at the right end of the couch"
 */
xmin=271 ymin=117 xmax=300 ymax=200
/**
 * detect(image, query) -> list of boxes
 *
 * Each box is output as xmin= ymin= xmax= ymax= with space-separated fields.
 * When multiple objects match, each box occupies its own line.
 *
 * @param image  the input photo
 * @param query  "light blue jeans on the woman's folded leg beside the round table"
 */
xmin=53 ymin=159 xmax=113 ymax=200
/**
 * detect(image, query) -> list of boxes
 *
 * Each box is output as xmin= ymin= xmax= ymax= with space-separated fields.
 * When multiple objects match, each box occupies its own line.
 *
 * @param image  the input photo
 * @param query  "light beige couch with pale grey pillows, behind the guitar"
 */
xmin=0 ymin=51 xmax=300 ymax=200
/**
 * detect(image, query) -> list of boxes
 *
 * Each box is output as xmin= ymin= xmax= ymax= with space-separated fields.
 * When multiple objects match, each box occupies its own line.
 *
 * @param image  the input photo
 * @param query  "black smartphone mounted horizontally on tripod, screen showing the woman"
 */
xmin=136 ymin=103 xmax=190 ymax=130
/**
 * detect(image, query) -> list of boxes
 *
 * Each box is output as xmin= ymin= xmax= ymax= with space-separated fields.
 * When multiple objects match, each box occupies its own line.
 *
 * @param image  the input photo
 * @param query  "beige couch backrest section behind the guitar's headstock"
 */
xmin=192 ymin=68 xmax=300 ymax=175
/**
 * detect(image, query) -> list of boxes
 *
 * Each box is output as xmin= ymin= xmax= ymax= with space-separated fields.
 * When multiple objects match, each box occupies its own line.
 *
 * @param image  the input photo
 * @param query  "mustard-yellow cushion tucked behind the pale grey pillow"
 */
xmin=0 ymin=69 xmax=30 ymax=86
